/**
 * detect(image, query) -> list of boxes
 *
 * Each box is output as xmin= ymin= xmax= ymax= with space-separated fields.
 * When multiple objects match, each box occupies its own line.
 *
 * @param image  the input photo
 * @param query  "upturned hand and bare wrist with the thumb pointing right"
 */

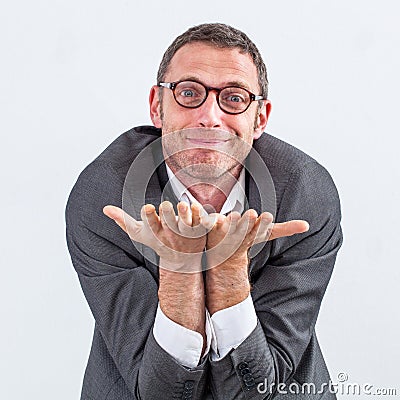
xmin=202 ymin=209 xmax=309 ymax=315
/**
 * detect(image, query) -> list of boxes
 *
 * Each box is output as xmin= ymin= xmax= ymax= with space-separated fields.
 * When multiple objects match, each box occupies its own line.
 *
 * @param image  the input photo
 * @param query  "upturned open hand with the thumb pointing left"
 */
xmin=103 ymin=201 xmax=206 ymax=272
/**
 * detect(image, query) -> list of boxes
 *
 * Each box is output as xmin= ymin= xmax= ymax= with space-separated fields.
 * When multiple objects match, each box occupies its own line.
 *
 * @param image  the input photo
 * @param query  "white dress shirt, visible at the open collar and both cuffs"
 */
xmin=153 ymin=164 xmax=257 ymax=368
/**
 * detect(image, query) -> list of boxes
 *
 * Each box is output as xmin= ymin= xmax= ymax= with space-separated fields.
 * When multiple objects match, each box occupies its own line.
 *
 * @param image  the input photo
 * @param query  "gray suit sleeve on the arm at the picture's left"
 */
xmin=66 ymin=161 xmax=206 ymax=400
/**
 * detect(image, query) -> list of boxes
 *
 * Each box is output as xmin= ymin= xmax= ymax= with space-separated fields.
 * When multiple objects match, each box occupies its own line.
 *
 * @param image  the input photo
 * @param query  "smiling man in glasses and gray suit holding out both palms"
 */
xmin=66 ymin=24 xmax=342 ymax=400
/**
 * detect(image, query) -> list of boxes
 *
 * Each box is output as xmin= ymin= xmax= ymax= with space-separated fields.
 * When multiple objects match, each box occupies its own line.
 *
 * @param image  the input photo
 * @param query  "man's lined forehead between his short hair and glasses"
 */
xmin=165 ymin=43 xmax=259 ymax=91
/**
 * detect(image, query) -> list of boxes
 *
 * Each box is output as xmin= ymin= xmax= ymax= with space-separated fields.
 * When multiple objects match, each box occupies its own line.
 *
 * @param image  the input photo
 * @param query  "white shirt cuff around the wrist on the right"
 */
xmin=211 ymin=294 xmax=257 ymax=361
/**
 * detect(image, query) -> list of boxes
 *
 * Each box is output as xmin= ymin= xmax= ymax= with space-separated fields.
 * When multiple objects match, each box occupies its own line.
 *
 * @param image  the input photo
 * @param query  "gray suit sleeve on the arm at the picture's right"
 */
xmin=210 ymin=162 xmax=342 ymax=400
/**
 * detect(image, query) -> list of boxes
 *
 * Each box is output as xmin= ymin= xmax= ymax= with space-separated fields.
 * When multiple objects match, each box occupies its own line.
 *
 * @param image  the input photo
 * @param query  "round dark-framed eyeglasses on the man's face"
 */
xmin=157 ymin=80 xmax=264 ymax=114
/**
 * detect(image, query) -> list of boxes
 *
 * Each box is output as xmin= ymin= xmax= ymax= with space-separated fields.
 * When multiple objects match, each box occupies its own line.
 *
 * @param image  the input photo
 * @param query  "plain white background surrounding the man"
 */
xmin=0 ymin=0 xmax=400 ymax=400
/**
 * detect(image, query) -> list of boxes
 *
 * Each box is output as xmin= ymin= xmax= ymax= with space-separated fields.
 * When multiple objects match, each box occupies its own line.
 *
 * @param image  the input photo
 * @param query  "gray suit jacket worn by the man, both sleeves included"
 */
xmin=66 ymin=126 xmax=342 ymax=400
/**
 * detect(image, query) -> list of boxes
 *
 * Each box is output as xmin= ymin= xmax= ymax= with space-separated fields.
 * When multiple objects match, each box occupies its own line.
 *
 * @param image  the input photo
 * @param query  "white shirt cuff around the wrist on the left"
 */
xmin=153 ymin=304 xmax=205 ymax=368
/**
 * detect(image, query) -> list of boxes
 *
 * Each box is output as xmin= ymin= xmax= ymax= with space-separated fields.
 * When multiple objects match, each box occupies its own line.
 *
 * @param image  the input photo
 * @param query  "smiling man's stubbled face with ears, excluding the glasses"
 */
xmin=150 ymin=43 xmax=270 ymax=179
